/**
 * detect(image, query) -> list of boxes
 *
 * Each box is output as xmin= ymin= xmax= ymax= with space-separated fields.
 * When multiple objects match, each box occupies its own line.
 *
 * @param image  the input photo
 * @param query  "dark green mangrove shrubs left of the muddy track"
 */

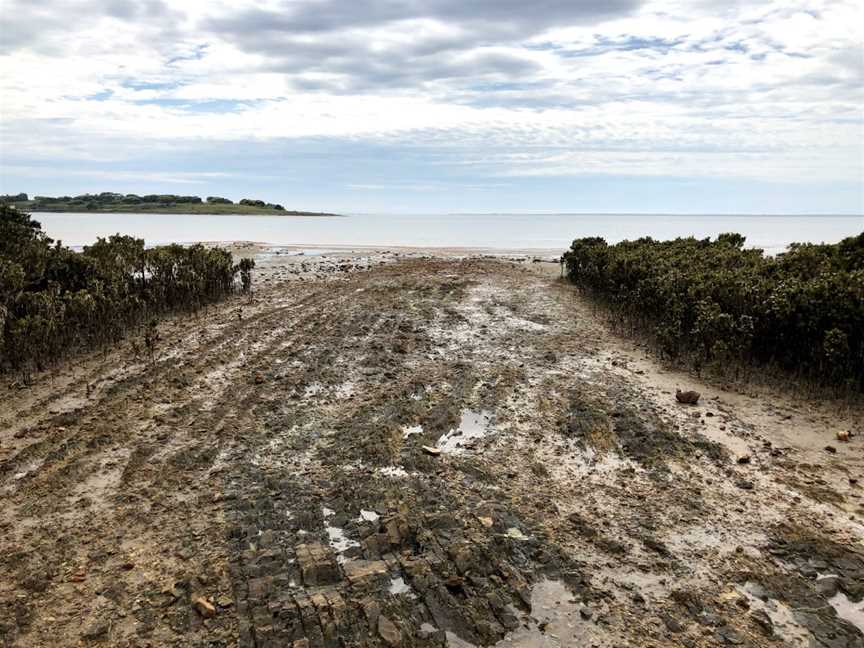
xmin=0 ymin=204 xmax=255 ymax=376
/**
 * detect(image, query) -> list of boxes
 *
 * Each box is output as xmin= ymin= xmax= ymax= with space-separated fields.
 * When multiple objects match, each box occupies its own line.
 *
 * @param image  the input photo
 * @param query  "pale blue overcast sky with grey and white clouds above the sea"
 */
xmin=0 ymin=0 xmax=864 ymax=213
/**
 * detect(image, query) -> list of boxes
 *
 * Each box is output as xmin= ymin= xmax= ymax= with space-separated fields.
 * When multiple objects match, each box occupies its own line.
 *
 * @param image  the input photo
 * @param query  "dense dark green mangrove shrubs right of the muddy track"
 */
xmin=563 ymin=234 xmax=864 ymax=391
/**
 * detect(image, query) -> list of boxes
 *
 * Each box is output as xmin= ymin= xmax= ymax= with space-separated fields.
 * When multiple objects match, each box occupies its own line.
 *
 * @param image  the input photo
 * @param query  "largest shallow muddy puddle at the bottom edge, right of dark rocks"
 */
xmin=446 ymin=580 xmax=597 ymax=648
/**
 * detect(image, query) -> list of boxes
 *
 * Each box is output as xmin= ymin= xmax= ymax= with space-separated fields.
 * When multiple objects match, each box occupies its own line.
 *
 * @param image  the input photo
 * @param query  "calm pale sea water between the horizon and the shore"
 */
xmin=33 ymin=213 xmax=864 ymax=253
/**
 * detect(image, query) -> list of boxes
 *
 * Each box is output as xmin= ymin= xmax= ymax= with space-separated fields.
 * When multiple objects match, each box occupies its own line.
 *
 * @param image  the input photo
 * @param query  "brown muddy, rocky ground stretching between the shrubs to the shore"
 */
xmin=0 ymin=250 xmax=864 ymax=648
